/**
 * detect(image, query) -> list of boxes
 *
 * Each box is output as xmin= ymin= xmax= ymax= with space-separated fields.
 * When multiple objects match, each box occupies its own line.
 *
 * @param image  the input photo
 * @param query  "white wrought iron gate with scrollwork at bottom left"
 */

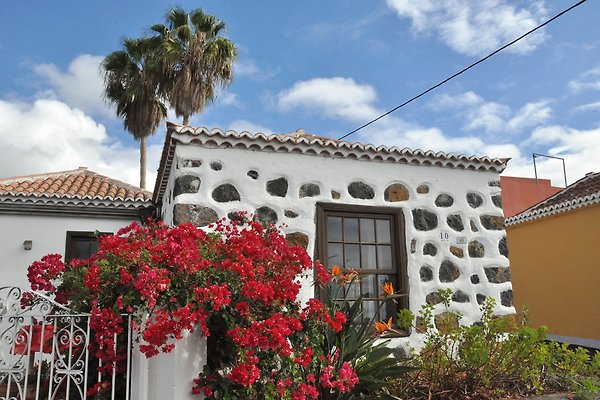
xmin=0 ymin=287 xmax=131 ymax=400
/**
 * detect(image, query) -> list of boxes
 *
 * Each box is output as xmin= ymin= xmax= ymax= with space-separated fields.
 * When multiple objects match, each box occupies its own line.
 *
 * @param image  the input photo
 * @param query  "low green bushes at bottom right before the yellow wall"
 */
xmin=394 ymin=290 xmax=600 ymax=400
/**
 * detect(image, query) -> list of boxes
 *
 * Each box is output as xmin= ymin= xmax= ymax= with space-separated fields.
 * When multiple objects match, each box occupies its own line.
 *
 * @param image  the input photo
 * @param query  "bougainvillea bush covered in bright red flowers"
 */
xmin=29 ymin=215 xmax=408 ymax=400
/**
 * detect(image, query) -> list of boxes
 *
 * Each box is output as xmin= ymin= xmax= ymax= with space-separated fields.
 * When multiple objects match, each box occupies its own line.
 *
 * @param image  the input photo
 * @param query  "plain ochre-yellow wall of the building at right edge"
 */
xmin=506 ymin=204 xmax=600 ymax=340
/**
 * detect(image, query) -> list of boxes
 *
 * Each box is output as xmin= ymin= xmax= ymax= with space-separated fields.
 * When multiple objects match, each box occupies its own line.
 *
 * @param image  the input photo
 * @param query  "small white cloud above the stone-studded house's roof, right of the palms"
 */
xmin=277 ymin=77 xmax=378 ymax=121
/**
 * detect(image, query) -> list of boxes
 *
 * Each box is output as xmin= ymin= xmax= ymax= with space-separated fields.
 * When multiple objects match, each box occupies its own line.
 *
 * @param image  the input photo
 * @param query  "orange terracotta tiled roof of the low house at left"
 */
xmin=0 ymin=167 xmax=152 ymax=203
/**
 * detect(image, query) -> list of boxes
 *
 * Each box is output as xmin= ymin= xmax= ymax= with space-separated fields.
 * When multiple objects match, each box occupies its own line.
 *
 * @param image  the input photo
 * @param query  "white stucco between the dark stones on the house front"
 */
xmin=162 ymin=143 xmax=514 ymax=350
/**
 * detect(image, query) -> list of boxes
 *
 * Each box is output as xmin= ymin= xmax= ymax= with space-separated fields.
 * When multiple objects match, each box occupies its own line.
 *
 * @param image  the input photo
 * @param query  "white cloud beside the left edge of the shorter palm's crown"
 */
xmin=33 ymin=54 xmax=114 ymax=117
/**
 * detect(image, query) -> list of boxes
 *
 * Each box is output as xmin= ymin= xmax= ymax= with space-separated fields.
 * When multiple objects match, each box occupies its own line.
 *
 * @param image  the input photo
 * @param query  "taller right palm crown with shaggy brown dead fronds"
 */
xmin=151 ymin=8 xmax=237 ymax=125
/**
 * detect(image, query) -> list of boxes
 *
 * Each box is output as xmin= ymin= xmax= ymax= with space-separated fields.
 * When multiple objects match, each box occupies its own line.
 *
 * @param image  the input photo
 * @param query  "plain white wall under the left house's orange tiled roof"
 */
xmin=0 ymin=214 xmax=139 ymax=288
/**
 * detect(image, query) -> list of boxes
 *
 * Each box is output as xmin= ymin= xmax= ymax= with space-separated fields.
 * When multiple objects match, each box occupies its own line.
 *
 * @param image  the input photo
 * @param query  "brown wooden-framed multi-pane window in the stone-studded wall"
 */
xmin=317 ymin=203 xmax=408 ymax=321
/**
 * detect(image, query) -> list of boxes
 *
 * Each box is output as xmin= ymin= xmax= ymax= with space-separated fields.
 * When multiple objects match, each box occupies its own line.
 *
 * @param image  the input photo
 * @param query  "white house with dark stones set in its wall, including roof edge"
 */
xmin=154 ymin=124 xmax=515 ymax=346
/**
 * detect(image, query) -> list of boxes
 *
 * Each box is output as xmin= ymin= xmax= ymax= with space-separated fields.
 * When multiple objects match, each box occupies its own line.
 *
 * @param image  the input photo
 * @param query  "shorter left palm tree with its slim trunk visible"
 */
xmin=101 ymin=38 xmax=167 ymax=189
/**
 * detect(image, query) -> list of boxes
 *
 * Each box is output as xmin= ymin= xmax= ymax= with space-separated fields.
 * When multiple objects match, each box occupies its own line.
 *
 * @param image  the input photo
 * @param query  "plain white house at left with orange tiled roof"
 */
xmin=0 ymin=167 xmax=152 ymax=288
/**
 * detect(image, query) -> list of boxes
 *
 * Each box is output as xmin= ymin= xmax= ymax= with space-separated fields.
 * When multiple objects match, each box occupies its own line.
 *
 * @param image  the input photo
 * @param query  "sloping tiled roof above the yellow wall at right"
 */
xmin=506 ymin=172 xmax=600 ymax=225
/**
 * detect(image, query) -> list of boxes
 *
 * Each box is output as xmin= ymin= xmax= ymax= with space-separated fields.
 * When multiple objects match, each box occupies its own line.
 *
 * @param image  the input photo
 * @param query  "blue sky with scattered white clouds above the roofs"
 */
xmin=0 ymin=0 xmax=600 ymax=189
